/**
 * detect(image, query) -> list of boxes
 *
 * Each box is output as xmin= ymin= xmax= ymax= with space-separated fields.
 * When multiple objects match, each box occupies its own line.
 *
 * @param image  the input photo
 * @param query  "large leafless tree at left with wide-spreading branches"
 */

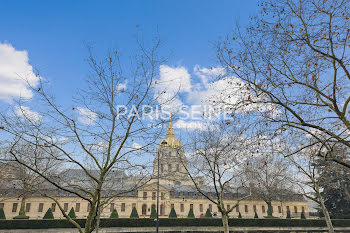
xmin=0 ymin=38 xmax=163 ymax=232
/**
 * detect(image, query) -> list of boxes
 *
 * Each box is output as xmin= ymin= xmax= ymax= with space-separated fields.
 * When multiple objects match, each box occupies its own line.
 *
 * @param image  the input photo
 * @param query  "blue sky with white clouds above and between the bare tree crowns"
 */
xmin=0 ymin=0 xmax=256 ymax=131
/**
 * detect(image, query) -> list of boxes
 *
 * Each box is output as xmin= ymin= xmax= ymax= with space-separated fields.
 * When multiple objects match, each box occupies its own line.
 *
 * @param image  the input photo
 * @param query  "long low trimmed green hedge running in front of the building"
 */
xmin=0 ymin=218 xmax=350 ymax=229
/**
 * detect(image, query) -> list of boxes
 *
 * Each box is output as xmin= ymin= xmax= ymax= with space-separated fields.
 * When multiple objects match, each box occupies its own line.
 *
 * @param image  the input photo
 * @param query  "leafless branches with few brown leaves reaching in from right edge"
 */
xmin=217 ymin=0 xmax=350 ymax=167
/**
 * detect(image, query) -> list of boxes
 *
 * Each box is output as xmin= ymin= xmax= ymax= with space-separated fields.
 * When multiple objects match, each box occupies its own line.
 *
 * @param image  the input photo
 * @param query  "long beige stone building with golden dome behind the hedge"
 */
xmin=0 ymin=122 xmax=309 ymax=219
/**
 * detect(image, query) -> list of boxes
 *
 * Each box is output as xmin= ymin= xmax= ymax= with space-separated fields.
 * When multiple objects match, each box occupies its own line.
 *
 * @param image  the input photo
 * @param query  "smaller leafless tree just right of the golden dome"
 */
xmin=179 ymin=122 xmax=250 ymax=233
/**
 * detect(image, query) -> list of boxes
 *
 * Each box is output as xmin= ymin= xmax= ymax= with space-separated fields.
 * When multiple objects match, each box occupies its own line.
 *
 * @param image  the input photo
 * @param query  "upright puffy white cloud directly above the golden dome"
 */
xmin=155 ymin=65 xmax=191 ymax=112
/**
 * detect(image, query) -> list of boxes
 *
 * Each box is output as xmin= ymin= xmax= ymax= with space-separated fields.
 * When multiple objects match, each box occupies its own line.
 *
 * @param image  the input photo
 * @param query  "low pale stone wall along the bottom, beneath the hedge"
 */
xmin=0 ymin=227 xmax=350 ymax=233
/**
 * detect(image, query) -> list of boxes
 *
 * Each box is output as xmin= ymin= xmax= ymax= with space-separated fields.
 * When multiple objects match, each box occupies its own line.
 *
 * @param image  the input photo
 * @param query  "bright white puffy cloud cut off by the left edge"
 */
xmin=0 ymin=43 xmax=40 ymax=102
